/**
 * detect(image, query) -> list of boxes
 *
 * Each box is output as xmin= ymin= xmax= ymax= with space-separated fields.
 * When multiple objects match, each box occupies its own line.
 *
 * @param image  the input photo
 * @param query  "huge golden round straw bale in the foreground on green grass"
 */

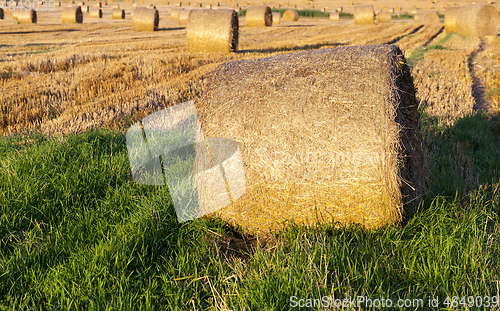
xmin=194 ymin=45 xmax=425 ymax=232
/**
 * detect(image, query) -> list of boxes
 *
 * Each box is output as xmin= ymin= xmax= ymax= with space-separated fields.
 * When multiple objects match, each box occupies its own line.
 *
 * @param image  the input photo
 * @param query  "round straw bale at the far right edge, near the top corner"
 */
xmin=456 ymin=4 xmax=500 ymax=38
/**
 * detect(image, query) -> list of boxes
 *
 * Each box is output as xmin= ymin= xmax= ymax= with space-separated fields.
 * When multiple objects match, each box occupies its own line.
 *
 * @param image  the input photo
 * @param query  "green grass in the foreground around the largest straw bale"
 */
xmin=0 ymin=108 xmax=500 ymax=310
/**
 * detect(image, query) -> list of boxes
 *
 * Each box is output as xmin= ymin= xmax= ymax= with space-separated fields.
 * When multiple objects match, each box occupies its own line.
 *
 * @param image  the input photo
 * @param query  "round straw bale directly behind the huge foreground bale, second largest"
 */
xmin=186 ymin=10 xmax=238 ymax=53
